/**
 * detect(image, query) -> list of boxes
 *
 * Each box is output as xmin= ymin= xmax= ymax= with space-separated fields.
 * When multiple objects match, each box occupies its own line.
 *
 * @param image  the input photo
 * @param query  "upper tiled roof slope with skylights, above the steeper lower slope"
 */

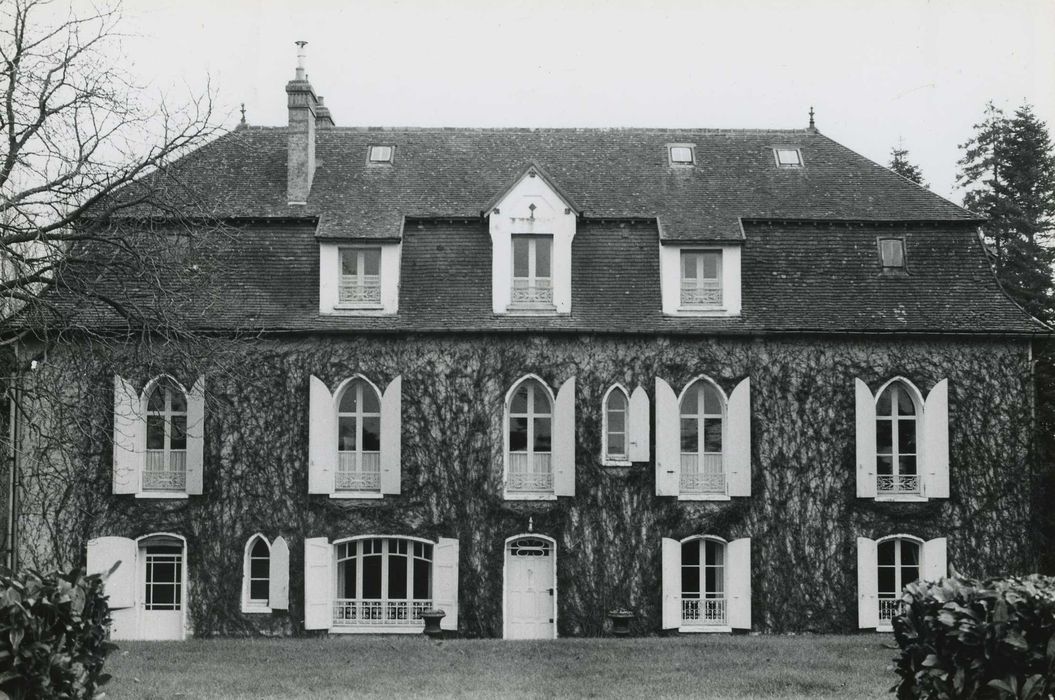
xmin=131 ymin=127 xmax=973 ymax=240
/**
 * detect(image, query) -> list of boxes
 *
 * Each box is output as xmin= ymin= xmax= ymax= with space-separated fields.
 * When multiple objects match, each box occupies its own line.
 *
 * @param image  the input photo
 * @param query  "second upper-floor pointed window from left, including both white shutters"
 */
xmin=308 ymin=375 xmax=403 ymax=499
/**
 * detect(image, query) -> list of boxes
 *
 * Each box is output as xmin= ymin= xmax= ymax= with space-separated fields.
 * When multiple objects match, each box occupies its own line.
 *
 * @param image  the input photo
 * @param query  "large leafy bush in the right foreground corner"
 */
xmin=891 ymin=575 xmax=1055 ymax=700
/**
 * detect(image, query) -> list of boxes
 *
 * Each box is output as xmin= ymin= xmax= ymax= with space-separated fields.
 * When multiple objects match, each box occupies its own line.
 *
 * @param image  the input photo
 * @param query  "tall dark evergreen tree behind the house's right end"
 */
xmin=958 ymin=102 xmax=1055 ymax=322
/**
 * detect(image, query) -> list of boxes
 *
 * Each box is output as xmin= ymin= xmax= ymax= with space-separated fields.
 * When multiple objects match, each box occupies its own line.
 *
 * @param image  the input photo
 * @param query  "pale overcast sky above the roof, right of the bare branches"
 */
xmin=107 ymin=0 xmax=1055 ymax=201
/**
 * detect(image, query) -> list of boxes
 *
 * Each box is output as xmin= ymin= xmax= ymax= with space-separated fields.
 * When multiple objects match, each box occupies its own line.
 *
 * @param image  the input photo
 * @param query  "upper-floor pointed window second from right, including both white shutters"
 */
xmin=656 ymin=377 xmax=751 ymax=500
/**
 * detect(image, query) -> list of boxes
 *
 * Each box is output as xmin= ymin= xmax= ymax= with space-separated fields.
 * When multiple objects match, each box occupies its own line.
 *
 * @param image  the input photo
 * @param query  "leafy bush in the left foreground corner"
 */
xmin=0 ymin=568 xmax=116 ymax=699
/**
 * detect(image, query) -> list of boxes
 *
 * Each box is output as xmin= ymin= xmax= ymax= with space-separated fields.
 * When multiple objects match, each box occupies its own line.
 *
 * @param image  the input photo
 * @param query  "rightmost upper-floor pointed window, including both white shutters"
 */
xmin=855 ymin=377 xmax=948 ymax=501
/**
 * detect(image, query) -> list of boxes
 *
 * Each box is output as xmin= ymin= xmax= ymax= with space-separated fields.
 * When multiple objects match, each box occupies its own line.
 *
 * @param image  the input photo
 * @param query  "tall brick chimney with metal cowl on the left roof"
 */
xmin=286 ymin=41 xmax=318 ymax=205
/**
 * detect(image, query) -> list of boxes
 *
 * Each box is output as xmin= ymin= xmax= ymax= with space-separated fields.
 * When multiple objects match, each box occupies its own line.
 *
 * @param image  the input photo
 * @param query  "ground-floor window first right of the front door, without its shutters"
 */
xmin=682 ymin=538 xmax=727 ymax=626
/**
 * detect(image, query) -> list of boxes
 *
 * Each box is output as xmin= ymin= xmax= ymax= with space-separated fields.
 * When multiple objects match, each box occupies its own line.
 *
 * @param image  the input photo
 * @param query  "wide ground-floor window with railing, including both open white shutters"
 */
xmin=304 ymin=537 xmax=459 ymax=634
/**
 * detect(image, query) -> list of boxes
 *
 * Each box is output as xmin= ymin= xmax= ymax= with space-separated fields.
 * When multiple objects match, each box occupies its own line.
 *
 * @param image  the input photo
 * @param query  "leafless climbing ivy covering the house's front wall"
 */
xmin=12 ymin=334 xmax=1037 ymax=637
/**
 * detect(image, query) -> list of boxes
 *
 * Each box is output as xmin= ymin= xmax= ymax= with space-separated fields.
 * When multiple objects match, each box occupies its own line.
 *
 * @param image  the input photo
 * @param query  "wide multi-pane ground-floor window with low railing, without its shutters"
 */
xmin=333 ymin=538 xmax=433 ymax=627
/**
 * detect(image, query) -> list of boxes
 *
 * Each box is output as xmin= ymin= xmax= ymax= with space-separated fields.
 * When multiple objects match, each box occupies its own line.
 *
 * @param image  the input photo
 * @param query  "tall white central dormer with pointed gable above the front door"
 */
xmin=485 ymin=163 xmax=578 ymax=315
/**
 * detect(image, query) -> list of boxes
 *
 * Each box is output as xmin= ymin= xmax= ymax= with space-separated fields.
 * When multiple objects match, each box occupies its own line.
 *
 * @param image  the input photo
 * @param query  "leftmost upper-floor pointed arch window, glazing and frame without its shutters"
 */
xmin=142 ymin=376 xmax=187 ymax=491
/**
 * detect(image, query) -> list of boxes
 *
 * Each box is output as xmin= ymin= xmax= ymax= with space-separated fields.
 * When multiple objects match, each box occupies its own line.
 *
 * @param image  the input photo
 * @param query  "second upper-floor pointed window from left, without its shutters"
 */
xmin=335 ymin=377 xmax=381 ymax=491
